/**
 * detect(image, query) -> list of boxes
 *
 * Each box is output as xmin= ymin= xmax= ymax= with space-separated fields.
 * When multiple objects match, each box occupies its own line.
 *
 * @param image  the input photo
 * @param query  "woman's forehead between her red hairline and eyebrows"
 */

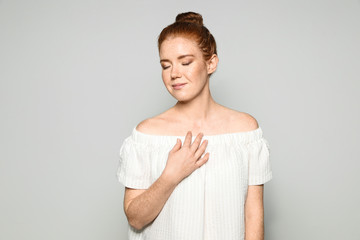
xmin=159 ymin=37 xmax=201 ymax=59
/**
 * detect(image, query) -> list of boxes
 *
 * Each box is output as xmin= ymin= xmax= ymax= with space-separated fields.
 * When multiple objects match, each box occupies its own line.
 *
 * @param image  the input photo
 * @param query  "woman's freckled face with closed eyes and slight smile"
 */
xmin=160 ymin=37 xmax=209 ymax=101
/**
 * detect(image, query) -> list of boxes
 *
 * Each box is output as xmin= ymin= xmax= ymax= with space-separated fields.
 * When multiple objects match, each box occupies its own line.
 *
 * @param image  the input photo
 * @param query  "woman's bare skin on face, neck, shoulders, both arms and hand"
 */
xmin=124 ymin=37 xmax=264 ymax=240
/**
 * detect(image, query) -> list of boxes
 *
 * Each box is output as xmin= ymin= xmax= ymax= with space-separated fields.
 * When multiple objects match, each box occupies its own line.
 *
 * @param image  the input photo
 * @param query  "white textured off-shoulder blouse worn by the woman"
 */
xmin=117 ymin=127 xmax=272 ymax=240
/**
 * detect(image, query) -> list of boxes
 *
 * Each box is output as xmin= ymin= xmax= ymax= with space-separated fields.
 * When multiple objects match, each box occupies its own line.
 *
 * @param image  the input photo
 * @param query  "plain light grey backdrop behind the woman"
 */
xmin=0 ymin=0 xmax=360 ymax=240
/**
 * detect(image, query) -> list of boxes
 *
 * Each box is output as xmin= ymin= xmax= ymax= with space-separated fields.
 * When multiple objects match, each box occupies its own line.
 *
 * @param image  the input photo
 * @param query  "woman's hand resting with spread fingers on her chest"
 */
xmin=163 ymin=131 xmax=210 ymax=184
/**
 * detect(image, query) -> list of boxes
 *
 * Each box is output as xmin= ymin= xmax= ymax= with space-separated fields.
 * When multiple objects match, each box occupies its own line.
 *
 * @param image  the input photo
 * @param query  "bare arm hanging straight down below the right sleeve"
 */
xmin=245 ymin=184 xmax=264 ymax=240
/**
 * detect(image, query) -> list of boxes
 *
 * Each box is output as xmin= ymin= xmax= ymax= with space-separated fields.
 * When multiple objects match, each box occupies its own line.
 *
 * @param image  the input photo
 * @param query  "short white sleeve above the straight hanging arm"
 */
xmin=248 ymin=137 xmax=272 ymax=185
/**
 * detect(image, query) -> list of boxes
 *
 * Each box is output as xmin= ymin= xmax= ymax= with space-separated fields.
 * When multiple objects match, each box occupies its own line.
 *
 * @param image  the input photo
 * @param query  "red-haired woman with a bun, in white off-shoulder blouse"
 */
xmin=117 ymin=12 xmax=272 ymax=240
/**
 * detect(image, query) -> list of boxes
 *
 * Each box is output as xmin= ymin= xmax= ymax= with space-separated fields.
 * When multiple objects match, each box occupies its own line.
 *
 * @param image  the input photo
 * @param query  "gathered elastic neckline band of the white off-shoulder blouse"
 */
xmin=131 ymin=126 xmax=263 ymax=146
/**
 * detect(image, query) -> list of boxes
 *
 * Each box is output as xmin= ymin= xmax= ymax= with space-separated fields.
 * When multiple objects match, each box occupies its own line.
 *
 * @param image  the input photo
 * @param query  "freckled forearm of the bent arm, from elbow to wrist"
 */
xmin=127 ymin=173 xmax=177 ymax=229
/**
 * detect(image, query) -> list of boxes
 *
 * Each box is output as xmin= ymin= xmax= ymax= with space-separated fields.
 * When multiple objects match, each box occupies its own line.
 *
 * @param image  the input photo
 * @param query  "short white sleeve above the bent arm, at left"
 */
xmin=117 ymin=137 xmax=151 ymax=189
